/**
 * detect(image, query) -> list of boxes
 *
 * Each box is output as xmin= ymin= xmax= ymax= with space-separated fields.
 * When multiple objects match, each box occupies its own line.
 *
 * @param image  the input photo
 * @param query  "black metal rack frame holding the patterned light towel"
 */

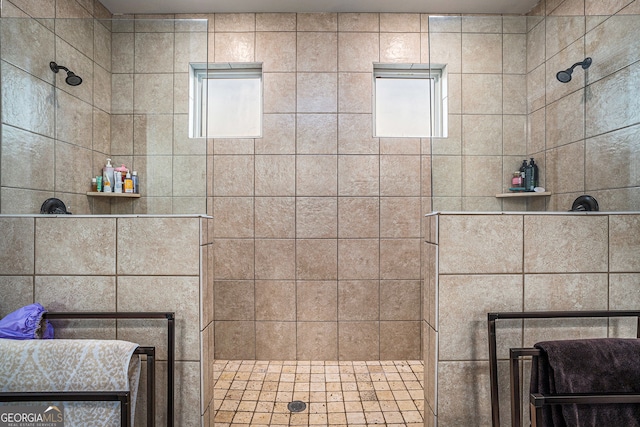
xmin=0 ymin=312 xmax=175 ymax=427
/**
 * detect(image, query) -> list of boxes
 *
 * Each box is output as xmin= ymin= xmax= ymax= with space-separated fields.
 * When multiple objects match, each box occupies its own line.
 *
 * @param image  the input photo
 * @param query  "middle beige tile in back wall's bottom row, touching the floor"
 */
xmin=296 ymin=322 xmax=338 ymax=360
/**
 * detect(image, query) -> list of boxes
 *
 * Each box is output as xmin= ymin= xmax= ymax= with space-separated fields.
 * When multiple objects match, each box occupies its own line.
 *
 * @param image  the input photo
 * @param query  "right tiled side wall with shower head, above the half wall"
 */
xmin=527 ymin=0 xmax=640 ymax=212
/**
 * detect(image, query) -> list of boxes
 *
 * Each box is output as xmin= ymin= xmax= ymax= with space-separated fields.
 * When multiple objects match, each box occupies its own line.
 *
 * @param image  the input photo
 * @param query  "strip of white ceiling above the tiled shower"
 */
xmin=101 ymin=0 xmax=539 ymax=14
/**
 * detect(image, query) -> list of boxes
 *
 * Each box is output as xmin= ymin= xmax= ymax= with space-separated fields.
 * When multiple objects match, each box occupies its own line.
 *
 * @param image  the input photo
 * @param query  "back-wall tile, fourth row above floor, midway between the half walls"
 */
xmin=296 ymin=197 xmax=338 ymax=238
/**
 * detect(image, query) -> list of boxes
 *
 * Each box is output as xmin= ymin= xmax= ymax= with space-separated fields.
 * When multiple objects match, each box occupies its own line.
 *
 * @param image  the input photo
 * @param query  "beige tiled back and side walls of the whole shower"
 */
xmin=0 ymin=0 xmax=640 ymax=426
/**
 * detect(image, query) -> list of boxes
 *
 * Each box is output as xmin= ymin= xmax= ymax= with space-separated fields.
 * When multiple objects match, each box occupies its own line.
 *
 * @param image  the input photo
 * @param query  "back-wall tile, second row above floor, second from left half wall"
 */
xmin=255 ymin=280 xmax=296 ymax=320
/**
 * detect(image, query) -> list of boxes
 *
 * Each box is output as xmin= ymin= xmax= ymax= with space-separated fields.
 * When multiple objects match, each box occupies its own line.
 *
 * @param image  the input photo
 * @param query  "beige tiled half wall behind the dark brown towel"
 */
xmin=424 ymin=213 xmax=640 ymax=427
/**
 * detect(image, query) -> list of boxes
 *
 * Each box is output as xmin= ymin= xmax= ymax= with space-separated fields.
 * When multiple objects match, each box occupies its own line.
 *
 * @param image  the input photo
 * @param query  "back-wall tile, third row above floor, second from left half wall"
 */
xmin=255 ymin=239 xmax=296 ymax=279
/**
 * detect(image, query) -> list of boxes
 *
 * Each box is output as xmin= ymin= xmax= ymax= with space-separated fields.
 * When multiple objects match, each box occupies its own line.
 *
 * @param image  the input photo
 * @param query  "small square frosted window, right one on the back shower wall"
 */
xmin=373 ymin=64 xmax=447 ymax=138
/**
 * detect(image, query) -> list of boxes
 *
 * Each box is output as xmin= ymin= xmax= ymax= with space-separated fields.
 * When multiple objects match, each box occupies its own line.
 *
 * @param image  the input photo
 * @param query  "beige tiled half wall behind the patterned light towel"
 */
xmin=0 ymin=215 xmax=213 ymax=426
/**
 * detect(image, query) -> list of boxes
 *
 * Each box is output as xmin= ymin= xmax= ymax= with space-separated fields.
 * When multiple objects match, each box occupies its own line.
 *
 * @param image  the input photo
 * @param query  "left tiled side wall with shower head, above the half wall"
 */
xmin=0 ymin=0 xmax=111 ymax=214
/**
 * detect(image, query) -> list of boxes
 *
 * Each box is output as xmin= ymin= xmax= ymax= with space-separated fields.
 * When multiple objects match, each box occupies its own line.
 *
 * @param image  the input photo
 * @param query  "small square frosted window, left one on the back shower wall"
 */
xmin=189 ymin=62 xmax=262 ymax=138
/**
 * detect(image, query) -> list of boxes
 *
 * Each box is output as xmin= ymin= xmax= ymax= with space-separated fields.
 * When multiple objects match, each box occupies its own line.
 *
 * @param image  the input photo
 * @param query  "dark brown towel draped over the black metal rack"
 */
xmin=530 ymin=338 xmax=640 ymax=427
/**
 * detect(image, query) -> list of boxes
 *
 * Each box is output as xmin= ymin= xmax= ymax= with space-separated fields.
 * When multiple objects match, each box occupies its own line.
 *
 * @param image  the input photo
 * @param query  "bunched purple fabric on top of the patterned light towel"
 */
xmin=0 ymin=303 xmax=53 ymax=340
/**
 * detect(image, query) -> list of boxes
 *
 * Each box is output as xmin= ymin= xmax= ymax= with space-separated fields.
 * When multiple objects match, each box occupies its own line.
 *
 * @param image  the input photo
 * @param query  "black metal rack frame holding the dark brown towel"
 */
xmin=487 ymin=310 xmax=640 ymax=427
